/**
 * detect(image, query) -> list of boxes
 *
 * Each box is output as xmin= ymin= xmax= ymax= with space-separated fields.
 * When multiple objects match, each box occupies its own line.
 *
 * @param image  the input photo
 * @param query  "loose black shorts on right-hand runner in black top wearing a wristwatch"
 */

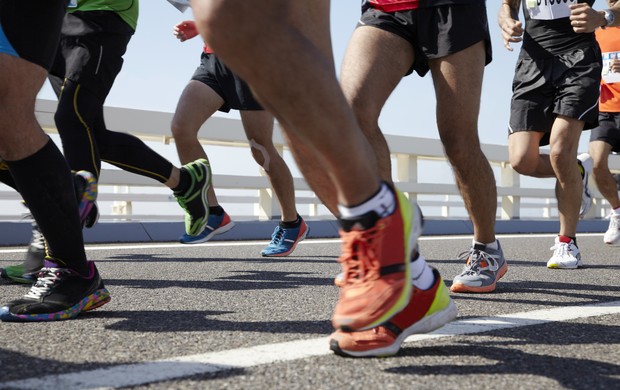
xmin=509 ymin=46 xmax=602 ymax=146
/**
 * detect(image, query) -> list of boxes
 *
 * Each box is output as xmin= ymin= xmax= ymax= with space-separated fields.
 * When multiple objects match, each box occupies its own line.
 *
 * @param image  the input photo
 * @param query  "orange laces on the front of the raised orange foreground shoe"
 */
xmin=338 ymin=227 xmax=381 ymax=285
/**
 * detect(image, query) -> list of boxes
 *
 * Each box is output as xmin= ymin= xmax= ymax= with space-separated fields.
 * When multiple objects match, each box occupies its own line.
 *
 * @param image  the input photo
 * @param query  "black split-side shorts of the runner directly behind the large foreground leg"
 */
xmin=358 ymin=3 xmax=492 ymax=76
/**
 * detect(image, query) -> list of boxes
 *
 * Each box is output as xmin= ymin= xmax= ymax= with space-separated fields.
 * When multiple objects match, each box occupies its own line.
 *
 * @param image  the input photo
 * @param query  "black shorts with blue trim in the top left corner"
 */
xmin=0 ymin=0 xmax=67 ymax=70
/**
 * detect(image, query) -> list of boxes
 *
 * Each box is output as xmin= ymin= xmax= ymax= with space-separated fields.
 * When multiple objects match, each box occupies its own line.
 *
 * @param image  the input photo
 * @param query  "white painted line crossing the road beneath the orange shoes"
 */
xmin=0 ymin=301 xmax=620 ymax=389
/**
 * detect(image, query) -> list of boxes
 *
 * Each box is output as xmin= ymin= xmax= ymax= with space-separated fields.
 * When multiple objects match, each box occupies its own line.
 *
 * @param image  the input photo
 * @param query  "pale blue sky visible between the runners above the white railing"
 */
xmin=40 ymin=0 xmax=548 ymax=148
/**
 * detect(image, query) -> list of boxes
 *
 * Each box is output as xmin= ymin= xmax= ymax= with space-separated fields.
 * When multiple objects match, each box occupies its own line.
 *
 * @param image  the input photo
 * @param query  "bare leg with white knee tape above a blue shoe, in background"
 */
xmin=241 ymin=111 xmax=297 ymax=221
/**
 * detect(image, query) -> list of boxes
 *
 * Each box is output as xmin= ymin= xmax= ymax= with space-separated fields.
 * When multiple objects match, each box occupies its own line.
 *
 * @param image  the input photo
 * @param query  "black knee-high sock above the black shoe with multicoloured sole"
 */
xmin=7 ymin=140 xmax=89 ymax=275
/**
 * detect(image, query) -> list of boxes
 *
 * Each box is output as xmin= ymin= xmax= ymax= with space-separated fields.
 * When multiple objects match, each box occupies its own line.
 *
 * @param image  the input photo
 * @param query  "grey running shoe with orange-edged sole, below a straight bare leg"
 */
xmin=450 ymin=241 xmax=508 ymax=293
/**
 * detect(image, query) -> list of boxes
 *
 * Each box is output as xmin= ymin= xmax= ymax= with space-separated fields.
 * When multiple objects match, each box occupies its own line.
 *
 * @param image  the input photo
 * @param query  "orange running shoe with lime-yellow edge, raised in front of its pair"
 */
xmin=332 ymin=190 xmax=423 ymax=331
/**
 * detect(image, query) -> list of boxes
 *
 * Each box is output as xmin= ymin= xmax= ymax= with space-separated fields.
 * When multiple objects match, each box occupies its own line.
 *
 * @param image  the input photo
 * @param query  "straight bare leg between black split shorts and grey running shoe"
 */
xmin=429 ymin=41 xmax=497 ymax=243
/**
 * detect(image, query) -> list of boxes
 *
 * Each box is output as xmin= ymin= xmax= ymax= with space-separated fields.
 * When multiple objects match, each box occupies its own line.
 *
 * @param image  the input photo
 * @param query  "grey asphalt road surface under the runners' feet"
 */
xmin=0 ymin=234 xmax=620 ymax=389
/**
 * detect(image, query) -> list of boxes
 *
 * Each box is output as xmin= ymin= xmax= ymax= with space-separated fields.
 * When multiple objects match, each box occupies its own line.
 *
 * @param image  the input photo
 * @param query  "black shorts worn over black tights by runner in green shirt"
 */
xmin=50 ymin=11 xmax=133 ymax=98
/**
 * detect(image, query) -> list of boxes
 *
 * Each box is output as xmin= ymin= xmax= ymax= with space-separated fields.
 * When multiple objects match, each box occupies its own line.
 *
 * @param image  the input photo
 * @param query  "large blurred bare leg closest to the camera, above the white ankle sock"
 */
xmin=194 ymin=0 xmax=379 ymax=205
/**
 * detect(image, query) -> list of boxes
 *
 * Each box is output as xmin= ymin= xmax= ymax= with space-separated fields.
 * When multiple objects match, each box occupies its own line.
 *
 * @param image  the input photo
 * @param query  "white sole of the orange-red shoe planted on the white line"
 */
xmin=329 ymin=300 xmax=458 ymax=357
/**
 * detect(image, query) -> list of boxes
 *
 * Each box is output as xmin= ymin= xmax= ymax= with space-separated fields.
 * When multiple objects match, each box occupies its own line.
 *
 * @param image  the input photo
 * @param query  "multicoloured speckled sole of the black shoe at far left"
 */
xmin=0 ymin=288 xmax=111 ymax=322
